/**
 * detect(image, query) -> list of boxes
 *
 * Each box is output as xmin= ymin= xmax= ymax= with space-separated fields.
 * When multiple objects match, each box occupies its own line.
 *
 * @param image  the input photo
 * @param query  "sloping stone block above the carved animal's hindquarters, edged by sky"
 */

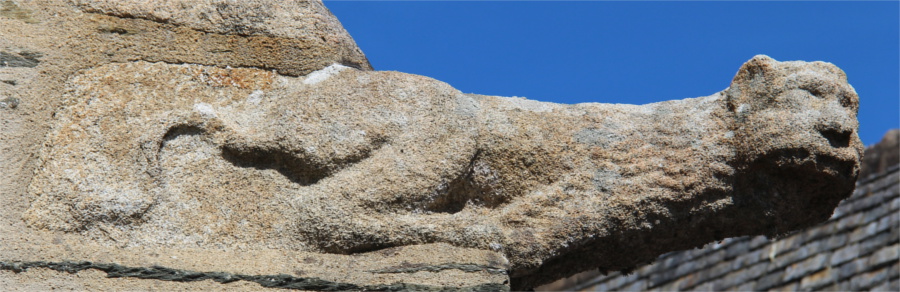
xmin=71 ymin=0 xmax=371 ymax=75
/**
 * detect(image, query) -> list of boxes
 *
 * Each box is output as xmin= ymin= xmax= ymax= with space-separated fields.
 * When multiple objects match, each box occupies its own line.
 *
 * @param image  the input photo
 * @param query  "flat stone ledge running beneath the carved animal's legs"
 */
xmin=0 ymin=238 xmax=509 ymax=291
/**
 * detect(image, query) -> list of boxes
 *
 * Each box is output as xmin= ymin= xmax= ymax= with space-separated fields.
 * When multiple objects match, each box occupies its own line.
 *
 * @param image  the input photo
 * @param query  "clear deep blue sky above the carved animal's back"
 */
xmin=325 ymin=0 xmax=900 ymax=145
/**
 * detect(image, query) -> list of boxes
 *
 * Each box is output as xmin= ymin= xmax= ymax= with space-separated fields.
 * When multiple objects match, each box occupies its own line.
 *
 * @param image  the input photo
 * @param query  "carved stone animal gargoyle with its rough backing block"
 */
xmin=24 ymin=56 xmax=862 ymax=288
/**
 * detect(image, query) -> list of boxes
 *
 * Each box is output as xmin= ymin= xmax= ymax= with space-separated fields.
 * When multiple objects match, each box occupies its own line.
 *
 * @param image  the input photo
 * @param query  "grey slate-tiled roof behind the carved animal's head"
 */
xmin=538 ymin=130 xmax=900 ymax=291
